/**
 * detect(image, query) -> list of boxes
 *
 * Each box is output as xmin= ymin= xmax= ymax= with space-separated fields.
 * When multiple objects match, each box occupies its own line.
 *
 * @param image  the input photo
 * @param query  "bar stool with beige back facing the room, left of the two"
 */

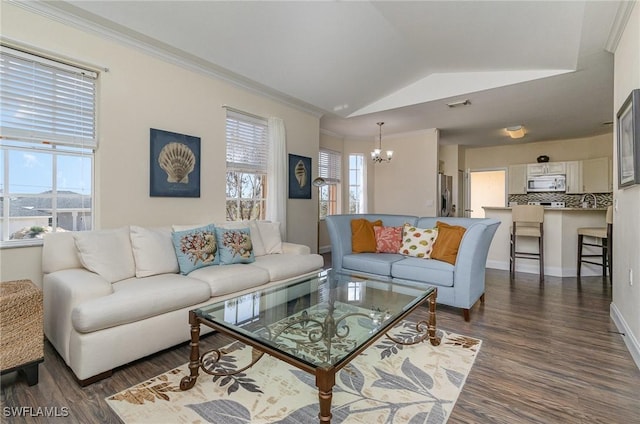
xmin=509 ymin=205 xmax=544 ymax=282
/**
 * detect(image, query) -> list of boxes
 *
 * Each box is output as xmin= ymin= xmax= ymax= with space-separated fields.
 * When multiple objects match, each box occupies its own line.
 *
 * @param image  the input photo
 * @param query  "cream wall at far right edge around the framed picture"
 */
xmin=611 ymin=3 xmax=640 ymax=368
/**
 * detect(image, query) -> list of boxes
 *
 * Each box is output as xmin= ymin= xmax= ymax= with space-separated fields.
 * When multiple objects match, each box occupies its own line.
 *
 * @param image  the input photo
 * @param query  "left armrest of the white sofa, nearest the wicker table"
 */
xmin=42 ymin=268 xmax=113 ymax=364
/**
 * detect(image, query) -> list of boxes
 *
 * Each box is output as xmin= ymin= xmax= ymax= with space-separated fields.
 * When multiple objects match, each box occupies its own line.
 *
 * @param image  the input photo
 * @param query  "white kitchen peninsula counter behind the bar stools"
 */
xmin=483 ymin=206 xmax=607 ymax=277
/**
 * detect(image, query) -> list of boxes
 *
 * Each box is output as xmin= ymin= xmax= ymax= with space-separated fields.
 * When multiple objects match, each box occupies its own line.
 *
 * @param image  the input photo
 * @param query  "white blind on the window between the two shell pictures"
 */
xmin=227 ymin=110 xmax=269 ymax=174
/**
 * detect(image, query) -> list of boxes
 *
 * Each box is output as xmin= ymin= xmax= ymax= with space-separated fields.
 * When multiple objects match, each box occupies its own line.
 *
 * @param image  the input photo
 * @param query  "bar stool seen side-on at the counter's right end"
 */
xmin=578 ymin=206 xmax=613 ymax=281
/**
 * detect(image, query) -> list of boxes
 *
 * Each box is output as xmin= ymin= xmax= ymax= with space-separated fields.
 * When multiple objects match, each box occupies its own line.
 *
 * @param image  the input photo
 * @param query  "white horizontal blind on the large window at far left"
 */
xmin=0 ymin=46 xmax=98 ymax=148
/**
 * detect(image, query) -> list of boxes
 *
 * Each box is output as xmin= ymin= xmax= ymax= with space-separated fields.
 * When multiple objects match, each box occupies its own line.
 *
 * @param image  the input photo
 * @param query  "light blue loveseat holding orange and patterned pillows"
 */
xmin=326 ymin=214 xmax=500 ymax=321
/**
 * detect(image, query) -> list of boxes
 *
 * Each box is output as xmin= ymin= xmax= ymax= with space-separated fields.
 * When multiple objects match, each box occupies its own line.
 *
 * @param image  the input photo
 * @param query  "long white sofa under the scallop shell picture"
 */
xmin=42 ymin=221 xmax=324 ymax=385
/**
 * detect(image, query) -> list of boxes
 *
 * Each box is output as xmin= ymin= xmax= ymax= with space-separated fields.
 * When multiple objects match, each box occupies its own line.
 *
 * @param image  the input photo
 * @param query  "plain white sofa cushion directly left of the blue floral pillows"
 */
xmin=130 ymin=225 xmax=180 ymax=278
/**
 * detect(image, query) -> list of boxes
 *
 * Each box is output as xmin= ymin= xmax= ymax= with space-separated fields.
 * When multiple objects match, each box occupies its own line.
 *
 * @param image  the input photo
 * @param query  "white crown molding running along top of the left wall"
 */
xmin=7 ymin=0 xmax=326 ymax=119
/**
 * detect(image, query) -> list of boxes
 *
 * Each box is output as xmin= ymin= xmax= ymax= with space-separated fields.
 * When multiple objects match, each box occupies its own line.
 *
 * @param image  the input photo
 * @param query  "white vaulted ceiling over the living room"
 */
xmin=32 ymin=1 xmax=623 ymax=146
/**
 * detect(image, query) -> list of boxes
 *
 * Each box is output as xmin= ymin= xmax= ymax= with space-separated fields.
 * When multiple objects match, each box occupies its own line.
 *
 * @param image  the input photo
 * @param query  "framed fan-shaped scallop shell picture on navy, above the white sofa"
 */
xmin=149 ymin=128 xmax=200 ymax=197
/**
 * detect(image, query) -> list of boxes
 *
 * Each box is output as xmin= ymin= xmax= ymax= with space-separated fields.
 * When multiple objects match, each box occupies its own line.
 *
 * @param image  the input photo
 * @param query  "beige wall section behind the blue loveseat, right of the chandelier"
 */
xmin=370 ymin=129 xmax=438 ymax=216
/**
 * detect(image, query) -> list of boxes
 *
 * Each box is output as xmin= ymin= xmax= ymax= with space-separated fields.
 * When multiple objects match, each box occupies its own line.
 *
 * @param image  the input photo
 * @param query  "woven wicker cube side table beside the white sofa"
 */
xmin=0 ymin=280 xmax=44 ymax=371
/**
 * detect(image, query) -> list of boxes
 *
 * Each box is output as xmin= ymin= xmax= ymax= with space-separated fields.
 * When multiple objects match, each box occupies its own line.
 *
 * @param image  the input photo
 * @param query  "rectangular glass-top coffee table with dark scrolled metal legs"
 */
xmin=180 ymin=270 xmax=440 ymax=423
